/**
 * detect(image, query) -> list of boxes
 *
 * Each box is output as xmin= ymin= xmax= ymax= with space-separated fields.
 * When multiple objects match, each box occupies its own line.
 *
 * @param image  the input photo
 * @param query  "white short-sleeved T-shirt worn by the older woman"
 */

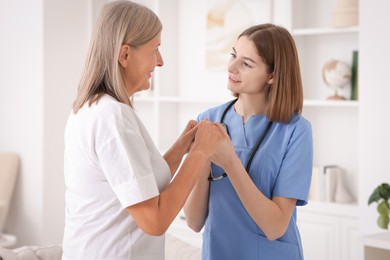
xmin=63 ymin=95 xmax=171 ymax=260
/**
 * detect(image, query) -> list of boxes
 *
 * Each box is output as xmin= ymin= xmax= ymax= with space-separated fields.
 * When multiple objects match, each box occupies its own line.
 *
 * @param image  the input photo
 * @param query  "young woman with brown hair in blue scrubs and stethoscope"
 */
xmin=184 ymin=24 xmax=313 ymax=260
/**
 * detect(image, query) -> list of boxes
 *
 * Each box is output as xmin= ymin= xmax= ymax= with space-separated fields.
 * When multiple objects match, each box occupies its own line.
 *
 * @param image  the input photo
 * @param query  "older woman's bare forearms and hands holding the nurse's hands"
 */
xmin=128 ymin=120 xmax=226 ymax=235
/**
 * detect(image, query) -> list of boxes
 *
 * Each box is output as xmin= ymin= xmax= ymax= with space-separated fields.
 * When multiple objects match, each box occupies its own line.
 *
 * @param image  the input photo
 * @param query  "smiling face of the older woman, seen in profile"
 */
xmin=119 ymin=33 xmax=164 ymax=97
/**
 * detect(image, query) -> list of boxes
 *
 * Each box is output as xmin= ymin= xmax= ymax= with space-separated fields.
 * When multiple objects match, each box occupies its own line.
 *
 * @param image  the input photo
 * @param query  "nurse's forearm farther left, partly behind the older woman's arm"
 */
xmin=184 ymin=170 xmax=210 ymax=232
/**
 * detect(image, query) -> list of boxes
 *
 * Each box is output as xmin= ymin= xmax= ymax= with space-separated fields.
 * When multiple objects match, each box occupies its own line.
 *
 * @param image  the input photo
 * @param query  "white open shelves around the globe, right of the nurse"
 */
xmin=286 ymin=0 xmax=359 ymax=202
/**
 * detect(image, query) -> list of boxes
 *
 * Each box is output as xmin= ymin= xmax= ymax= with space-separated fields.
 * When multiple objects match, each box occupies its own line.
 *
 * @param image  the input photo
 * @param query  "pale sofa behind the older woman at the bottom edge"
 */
xmin=0 ymin=234 xmax=201 ymax=260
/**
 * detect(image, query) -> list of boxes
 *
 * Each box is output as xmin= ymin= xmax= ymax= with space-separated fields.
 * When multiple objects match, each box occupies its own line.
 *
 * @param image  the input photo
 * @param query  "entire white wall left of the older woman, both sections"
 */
xmin=0 ymin=0 xmax=88 ymax=245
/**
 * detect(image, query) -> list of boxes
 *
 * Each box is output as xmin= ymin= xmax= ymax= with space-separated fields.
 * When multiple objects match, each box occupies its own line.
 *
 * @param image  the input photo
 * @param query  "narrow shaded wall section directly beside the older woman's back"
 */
xmin=42 ymin=0 xmax=89 ymax=244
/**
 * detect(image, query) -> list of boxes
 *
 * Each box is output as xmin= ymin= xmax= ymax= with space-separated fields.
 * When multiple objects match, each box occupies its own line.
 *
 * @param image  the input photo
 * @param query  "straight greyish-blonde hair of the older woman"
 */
xmin=73 ymin=0 xmax=162 ymax=113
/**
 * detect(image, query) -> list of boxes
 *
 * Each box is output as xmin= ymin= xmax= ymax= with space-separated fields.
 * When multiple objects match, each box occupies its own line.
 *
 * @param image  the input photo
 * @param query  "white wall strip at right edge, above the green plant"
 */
xmin=359 ymin=0 xmax=390 ymax=233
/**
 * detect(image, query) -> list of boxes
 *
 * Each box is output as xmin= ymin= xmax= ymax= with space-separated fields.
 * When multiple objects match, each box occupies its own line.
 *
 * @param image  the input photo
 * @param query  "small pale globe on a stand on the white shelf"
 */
xmin=322 ymin=59 xmax=352 ymax=100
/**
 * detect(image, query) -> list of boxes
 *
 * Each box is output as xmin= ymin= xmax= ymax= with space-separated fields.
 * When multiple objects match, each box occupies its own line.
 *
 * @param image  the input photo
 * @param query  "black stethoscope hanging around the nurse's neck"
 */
xmin=208 ymin=98 xmax=272 ymax=181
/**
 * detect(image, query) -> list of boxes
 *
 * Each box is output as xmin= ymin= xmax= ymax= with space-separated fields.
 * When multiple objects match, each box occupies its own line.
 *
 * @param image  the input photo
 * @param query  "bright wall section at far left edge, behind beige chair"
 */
xmin=0 ymin=0 xmax=44 ymax=246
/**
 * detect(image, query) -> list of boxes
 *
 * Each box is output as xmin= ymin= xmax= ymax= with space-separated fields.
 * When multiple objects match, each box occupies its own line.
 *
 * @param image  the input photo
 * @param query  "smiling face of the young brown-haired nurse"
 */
xmin=228 ymin=36 xmax=273 ymax=95
